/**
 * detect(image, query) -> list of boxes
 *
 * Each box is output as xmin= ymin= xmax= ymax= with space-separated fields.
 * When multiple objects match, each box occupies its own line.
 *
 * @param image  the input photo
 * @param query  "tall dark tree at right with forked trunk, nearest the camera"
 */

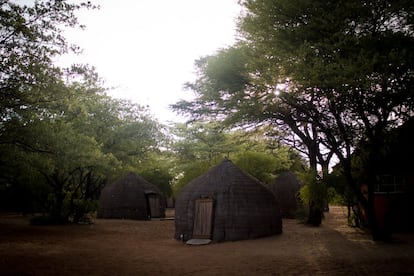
xmin=241 ymin=1 xmax=414 ymax=239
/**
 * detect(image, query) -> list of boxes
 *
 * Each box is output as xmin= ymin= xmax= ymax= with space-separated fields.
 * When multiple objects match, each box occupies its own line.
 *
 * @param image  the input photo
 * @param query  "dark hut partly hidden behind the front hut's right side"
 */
xmin=270 ymin=171 xmax=302 ymax=218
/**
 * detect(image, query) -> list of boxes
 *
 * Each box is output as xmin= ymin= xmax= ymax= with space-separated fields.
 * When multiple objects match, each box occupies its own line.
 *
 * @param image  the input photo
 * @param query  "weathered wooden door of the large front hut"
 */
xmin=193 ymin=198 xmax=214 ymax=239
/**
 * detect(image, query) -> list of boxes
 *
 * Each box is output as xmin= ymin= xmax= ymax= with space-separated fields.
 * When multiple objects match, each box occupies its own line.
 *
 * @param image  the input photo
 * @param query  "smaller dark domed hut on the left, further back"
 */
xmin=98 ymin=172 xmax=165 ymax=220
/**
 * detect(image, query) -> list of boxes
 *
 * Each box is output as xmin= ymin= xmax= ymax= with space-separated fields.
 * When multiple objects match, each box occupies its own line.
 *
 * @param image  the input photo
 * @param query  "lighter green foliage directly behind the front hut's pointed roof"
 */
xmin=169 ymin=121 xmax=303 ymax=194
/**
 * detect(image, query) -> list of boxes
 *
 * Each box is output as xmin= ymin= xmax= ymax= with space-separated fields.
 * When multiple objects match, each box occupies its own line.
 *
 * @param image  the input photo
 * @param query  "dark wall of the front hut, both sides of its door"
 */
xmin=175 ymin=187 xmax=282 ymax=241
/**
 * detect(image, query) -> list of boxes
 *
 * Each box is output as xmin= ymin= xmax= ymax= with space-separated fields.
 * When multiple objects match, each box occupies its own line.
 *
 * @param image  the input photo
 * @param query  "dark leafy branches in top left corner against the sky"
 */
xmin=0 ymin=1 xmax=94 ymax=143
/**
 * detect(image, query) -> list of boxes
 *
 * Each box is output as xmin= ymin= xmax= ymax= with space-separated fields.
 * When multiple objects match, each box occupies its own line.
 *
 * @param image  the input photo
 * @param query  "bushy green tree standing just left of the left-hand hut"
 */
xmin=7 ymin=86 xmax=166 ymax=222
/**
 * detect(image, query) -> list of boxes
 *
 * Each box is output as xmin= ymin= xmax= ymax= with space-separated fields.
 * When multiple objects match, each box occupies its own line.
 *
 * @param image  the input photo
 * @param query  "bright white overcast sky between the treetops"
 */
xmin=58 ymin=0 xmax=241 ymax=123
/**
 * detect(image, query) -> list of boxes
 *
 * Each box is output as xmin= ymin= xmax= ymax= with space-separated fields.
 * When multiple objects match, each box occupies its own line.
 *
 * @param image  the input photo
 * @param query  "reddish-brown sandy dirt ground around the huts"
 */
xmin=0 ymin=207 xmax=414 ymax=275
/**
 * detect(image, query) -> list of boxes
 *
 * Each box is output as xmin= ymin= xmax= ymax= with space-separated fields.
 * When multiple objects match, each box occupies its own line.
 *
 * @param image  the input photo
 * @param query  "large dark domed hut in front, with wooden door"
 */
xmin=175 ymin=160 xmax=282 ymax=241
